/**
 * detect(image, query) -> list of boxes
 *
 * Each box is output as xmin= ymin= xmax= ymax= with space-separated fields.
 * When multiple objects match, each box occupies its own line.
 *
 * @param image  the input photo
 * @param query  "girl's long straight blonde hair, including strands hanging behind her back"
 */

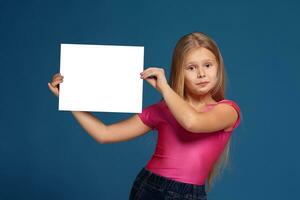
xmin=163 ymin=32 xmax=231 ymax=191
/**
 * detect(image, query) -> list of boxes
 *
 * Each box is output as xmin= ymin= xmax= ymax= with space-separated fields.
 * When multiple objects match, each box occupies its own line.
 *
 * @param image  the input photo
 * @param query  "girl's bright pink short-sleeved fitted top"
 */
xmin=138 ymin=99 xmax=240 ymax=185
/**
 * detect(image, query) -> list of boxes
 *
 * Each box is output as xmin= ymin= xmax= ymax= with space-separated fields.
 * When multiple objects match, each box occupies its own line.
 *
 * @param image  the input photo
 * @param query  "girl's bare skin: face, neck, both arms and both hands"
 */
xmin=48 ymin=48 xmax=237 ymax=144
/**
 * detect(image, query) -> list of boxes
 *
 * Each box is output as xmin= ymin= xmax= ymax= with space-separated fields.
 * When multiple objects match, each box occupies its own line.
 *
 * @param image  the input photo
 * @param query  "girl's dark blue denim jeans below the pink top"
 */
xmin=129 ymin=167 xmax=207 ymax=200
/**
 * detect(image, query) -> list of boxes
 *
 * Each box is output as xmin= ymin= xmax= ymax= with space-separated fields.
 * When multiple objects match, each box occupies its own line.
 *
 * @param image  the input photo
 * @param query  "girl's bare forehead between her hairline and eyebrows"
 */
xmin=184 ymin=47 xmax=216 ymax=63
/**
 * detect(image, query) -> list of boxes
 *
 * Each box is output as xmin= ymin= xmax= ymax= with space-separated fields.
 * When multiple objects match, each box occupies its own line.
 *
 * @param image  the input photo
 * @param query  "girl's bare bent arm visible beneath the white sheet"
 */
xmin=72 ymin=111 xmax=151 ymax=144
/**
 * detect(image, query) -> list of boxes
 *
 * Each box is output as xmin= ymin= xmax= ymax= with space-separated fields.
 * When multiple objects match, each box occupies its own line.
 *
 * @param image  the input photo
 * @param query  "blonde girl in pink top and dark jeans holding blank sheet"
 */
xmin=48 ymin=32 xmax=240 ymax=200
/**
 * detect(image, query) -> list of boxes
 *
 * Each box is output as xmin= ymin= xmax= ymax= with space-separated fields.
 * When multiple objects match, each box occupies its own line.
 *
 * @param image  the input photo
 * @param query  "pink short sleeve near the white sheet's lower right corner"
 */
xmin=137 ymin=104 xmax=157 ymax=129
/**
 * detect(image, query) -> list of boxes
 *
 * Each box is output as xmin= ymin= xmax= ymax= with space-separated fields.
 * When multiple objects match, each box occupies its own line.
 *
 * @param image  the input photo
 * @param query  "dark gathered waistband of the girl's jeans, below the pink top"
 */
xmin=137 ymin=167 xmax=206 ymax=195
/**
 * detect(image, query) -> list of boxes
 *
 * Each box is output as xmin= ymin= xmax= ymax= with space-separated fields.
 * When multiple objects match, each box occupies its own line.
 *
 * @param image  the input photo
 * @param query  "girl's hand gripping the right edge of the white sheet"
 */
xmin=140 ymin=67 xmax=168 ymax=93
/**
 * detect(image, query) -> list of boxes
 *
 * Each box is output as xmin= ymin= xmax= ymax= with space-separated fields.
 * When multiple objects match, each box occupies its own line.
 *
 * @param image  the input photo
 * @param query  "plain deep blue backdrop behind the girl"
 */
xmin=0 ymin=0 xmax=300 ymax=200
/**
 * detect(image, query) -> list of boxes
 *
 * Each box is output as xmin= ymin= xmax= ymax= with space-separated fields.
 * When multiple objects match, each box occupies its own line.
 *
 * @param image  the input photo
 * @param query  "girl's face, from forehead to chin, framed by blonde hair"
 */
xmin=183 ymin=47 xmax=218 ymax=96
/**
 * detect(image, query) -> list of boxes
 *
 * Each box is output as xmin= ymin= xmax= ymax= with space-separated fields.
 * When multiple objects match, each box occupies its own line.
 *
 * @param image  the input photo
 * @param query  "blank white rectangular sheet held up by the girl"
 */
xmin=58 ymin=44 xmax=144 ymax=113
